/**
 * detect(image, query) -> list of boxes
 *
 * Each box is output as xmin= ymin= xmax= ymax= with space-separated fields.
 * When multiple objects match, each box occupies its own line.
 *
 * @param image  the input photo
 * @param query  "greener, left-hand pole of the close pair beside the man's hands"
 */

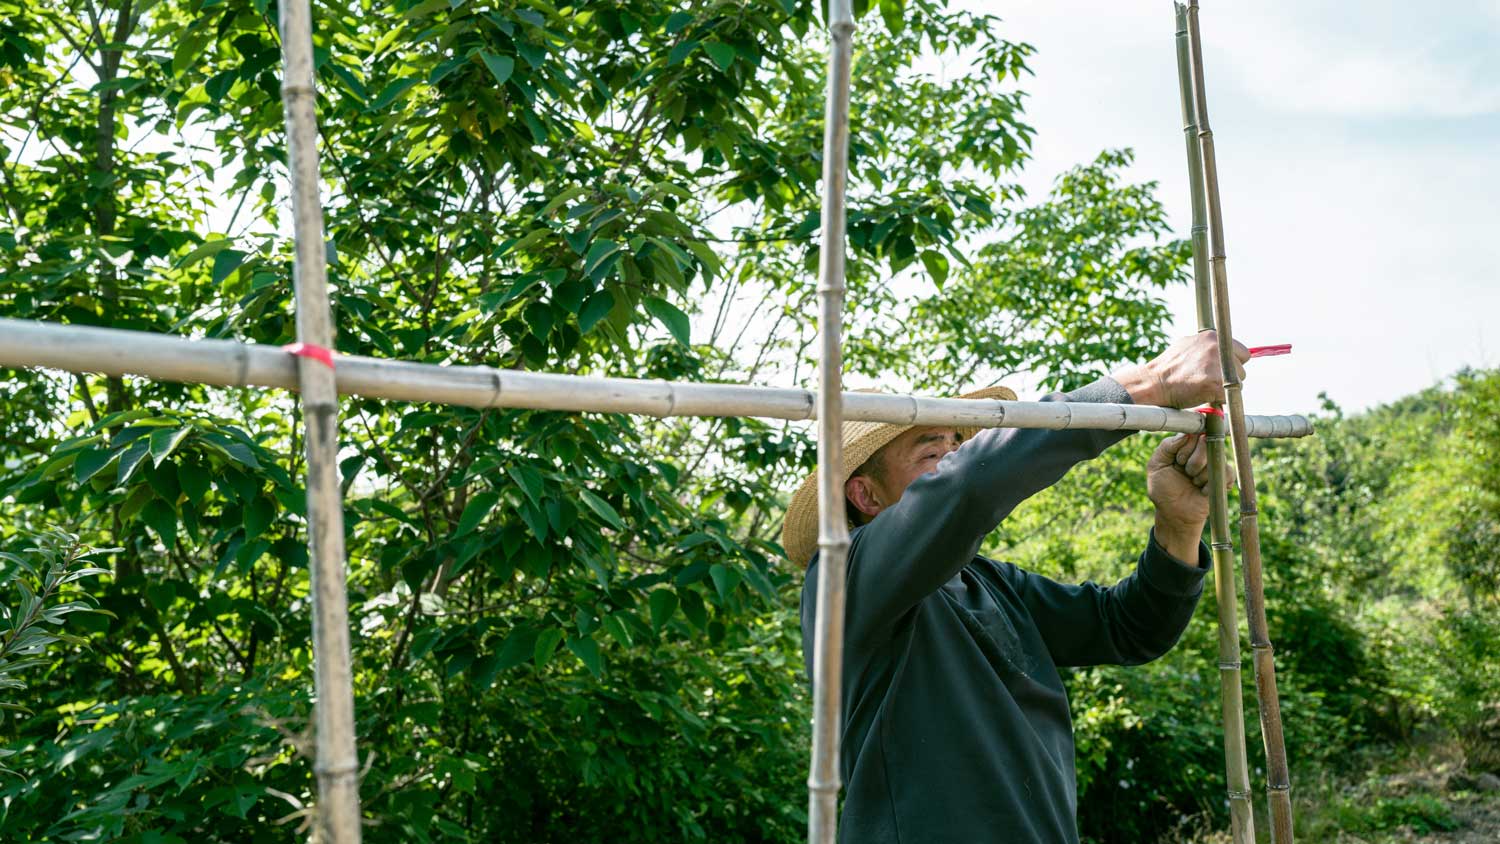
xmin=1173 ymin=3 xmax=1256 ymax=844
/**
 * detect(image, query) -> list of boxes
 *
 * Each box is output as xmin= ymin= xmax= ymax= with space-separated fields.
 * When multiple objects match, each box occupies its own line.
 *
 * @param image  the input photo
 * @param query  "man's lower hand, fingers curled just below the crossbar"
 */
xmin=1146 ymin=433 xmax=1233 ymax=565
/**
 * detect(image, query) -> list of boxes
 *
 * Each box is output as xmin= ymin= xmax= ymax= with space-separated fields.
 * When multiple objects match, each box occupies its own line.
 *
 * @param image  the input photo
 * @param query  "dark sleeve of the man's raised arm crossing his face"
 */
xmin=834 ymin=378 xmax=1131 ymax=646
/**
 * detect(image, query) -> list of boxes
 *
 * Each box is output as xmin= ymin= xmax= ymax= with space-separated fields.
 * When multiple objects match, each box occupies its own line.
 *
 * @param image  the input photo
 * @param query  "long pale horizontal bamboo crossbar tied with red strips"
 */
xmin=0 ymin=319 xmax=1313 ymax=438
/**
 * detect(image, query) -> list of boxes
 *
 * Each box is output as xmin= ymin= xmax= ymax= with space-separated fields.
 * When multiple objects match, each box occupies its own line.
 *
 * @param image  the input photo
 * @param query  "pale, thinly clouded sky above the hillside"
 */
xmin=965 ymin=0 xmax=1500 ymax=414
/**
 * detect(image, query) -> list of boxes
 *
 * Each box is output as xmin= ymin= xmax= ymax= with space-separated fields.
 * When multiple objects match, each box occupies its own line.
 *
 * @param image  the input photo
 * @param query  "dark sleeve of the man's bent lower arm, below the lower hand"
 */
xmin=1002 ymin=531 xmax=1212 ymax=666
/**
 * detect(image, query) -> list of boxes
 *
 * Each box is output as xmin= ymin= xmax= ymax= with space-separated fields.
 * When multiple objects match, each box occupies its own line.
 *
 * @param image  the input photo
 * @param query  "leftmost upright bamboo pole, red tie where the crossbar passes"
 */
xmin=281 ymin=0 xmax=360 ymax=844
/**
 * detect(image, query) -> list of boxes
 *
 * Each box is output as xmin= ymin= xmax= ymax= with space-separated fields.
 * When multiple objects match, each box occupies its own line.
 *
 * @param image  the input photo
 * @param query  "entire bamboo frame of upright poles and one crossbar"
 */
xmin=0 ymin=0 xmax=1313 ymax=844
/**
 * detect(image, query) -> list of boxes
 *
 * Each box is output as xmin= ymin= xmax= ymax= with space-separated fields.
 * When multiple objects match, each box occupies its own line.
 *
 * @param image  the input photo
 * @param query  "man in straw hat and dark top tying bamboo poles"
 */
xmin=782 ymin=331 xmax=1250 ymax=844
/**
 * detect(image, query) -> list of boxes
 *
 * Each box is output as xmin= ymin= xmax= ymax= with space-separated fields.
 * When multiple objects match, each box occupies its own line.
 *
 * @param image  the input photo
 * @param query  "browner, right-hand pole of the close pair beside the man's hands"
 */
xmin=1188 ymin=0 xmax=1293 ymax=844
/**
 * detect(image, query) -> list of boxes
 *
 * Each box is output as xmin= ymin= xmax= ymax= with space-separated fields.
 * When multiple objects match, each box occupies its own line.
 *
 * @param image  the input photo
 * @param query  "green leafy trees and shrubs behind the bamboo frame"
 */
xmin=0 ymin=0 xmax=1500 ymax=841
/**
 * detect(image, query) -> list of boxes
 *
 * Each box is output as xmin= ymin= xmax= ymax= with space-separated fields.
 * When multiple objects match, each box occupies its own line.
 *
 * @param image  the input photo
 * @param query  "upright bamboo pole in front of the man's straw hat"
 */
xmin=807 ymin=0 xmax=854 ymax=844
